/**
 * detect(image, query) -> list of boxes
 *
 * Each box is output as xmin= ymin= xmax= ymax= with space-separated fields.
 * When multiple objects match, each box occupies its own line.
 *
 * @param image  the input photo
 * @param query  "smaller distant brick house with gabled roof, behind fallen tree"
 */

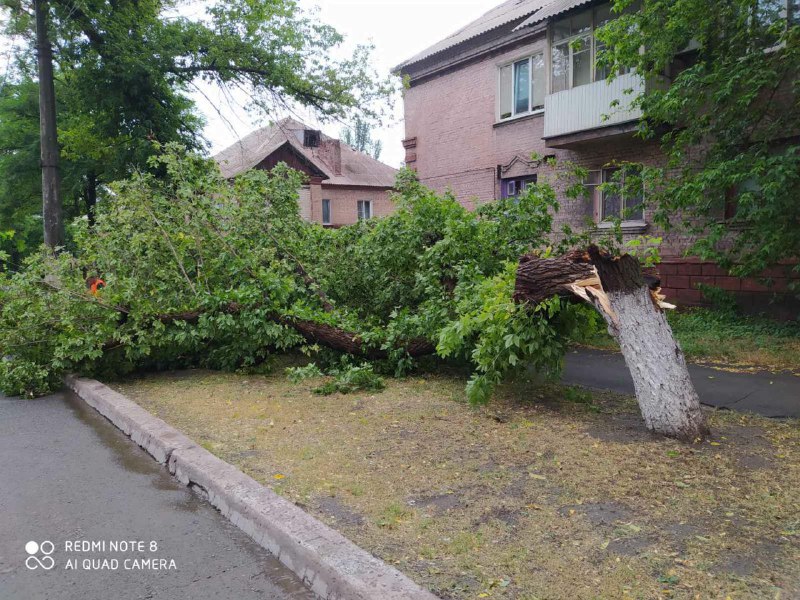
xmin=214 ymin=119 xmax=397 ymax=227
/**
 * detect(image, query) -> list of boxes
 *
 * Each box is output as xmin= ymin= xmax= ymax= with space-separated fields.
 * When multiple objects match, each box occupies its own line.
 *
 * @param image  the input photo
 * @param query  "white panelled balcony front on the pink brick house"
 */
xmin=544 ymin=73 xmax=645 ymax=148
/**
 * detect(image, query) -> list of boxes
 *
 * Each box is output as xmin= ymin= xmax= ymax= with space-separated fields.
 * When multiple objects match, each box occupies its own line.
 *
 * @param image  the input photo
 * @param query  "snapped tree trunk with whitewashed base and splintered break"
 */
xmin=514 ymin=246 xmax=708 ymax=440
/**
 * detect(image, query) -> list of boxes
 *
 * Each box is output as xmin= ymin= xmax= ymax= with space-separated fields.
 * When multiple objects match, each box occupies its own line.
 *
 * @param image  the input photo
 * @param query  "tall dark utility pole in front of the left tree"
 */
xmin=33 ymin=0 xmax=64 ymax=249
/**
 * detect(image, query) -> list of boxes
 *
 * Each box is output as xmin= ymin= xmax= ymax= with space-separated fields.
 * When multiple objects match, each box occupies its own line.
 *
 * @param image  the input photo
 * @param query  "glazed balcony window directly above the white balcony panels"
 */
xmin=550 ymin=3 xmax=632 ymax=93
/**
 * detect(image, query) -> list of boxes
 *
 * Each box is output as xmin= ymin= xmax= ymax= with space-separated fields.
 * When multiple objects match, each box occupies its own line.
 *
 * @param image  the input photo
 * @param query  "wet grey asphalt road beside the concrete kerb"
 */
xmin=0 ymin=394 xmax=313 ymax=600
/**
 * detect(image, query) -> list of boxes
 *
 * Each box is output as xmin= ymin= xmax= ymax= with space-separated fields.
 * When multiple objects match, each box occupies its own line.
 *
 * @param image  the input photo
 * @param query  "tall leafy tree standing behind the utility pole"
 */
xmin=0 ymin=0 xmax=391 ymax=258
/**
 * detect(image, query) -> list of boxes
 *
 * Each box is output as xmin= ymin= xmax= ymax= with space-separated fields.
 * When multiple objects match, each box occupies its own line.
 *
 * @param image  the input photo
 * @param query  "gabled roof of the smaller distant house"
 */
xmin=214 ymin=118 xmax=397 ymax=187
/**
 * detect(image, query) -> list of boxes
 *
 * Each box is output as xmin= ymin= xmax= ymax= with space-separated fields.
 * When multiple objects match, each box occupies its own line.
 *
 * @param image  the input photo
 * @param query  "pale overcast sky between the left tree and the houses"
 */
xmin=196 ymin=0 xmax=501 ymax=167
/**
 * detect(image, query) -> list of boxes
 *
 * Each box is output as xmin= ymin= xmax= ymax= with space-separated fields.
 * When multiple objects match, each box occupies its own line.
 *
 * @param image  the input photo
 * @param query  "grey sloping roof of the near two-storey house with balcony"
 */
xmin=394 ymin=0 xmax=590 ymax=71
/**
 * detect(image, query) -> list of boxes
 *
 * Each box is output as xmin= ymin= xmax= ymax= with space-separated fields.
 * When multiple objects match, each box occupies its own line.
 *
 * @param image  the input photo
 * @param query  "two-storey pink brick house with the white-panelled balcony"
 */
xmin=395 ymin=0 xmax=796 ymax=316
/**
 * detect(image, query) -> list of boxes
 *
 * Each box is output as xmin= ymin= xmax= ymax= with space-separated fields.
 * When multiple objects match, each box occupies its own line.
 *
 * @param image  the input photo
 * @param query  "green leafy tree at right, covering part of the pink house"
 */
xmin=598 ymin=0 xmax=800 ymax=288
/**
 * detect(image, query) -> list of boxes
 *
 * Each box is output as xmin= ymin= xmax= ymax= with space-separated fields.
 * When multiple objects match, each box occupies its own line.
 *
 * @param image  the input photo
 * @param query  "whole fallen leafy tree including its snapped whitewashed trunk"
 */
xmin=0 ymin=147 xmax=704 ymax=438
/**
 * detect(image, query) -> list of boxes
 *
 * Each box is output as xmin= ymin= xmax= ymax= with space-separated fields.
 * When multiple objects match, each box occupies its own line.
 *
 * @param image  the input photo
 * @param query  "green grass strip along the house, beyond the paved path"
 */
xmin=577 ymin=308 xmax=800 ymax=372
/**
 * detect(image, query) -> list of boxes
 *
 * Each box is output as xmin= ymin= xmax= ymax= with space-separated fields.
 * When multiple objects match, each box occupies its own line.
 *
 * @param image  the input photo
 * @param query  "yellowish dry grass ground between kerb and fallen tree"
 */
xmin=115 ymin=358 xmax=800 ymax=600
